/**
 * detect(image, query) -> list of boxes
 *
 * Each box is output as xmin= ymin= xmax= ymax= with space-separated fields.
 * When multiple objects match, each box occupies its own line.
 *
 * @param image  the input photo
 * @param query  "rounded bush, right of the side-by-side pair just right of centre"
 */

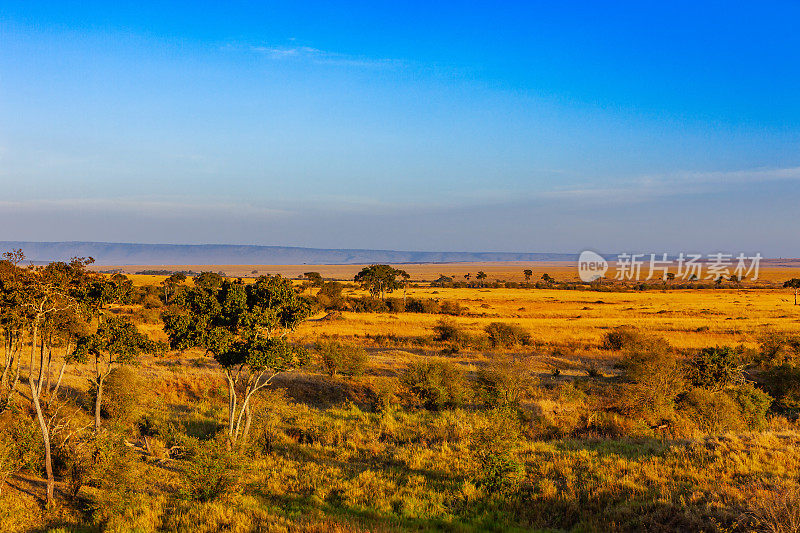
xmin=476 ymin=357 xmax=534 ymax=407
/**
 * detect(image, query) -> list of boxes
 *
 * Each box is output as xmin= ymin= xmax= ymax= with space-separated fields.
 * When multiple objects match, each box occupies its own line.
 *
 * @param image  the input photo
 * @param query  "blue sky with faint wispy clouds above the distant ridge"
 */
xmin=0 ymin=1 xmax=800 ymax=257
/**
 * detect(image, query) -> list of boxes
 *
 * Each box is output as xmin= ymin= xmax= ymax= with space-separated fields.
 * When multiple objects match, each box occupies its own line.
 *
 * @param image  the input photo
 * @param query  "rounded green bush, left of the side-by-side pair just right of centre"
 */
xmin=400 ymin=361 xmax=466 ymax=410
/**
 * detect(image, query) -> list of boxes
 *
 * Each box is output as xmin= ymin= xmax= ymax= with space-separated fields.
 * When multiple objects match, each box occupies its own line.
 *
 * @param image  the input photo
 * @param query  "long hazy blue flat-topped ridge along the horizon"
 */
xmin=0 ymin=241 xmax=578 ymax=265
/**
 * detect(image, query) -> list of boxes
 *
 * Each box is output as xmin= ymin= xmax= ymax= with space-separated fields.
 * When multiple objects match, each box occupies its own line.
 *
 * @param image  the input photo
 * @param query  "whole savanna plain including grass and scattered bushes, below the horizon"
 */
xmin=0 ymin=263 xmax=800 ymax=532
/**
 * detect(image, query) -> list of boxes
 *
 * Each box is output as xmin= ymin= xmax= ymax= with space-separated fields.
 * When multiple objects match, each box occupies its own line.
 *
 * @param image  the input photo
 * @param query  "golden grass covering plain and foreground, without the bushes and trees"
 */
xmin=6 ymin=262 xmax=800 ymax=532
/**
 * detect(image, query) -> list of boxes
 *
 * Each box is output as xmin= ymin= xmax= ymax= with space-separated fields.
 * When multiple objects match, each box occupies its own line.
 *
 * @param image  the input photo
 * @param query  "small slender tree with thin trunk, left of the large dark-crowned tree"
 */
xmin=75 ymin=316 xmax=154 ymax=431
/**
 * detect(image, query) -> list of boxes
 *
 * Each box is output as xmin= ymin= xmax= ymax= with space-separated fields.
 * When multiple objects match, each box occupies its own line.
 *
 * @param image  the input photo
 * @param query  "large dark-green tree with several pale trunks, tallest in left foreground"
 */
xmin=162 ymin=276 xmax=309 ymax=443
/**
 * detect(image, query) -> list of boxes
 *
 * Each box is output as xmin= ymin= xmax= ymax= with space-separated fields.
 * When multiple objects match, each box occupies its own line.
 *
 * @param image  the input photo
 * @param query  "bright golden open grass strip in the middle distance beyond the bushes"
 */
xmin=298 ymin=288 xmax=800 ymax=348
